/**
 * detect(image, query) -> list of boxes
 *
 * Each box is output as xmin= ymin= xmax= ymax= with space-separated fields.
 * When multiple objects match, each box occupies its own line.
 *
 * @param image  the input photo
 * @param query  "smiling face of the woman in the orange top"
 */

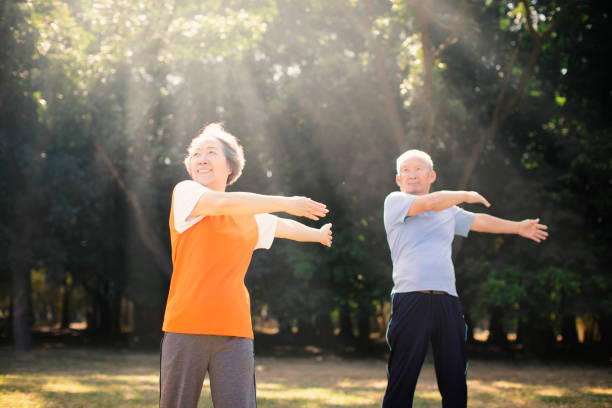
xmin=189 ymin=137 xmax=232 ymax=191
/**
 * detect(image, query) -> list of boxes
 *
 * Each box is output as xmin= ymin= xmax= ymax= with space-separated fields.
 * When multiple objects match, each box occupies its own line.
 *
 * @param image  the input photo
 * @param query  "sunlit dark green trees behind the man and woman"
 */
xmin=0 ymin=0 xmax=612 ymax=406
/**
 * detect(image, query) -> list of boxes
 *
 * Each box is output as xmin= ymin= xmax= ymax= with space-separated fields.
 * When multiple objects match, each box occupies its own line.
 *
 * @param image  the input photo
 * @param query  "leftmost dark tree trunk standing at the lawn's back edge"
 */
xmin=11 ymin=266 xmax=32 ymax=351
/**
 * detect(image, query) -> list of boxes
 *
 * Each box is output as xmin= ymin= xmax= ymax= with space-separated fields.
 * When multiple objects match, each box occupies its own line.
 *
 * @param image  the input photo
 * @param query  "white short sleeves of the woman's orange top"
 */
xmin=173 ymin=180 xmax=278 ymax=249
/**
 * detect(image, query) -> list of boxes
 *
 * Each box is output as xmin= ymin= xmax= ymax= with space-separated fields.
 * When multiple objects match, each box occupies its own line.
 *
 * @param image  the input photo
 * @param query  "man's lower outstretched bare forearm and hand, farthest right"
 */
xmin=470 ymin=213 xmax=548 ymax=242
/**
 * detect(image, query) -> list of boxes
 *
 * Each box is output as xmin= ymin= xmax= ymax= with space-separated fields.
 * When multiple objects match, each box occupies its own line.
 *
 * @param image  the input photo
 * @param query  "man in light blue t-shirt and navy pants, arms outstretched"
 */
xmin=383 ymin=150 xmax=548 ymax=408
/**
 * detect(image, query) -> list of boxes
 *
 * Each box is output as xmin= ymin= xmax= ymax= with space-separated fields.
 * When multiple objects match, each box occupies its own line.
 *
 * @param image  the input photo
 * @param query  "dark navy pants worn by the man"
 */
xmin=382 ymin=292 xmax=467 ymax=408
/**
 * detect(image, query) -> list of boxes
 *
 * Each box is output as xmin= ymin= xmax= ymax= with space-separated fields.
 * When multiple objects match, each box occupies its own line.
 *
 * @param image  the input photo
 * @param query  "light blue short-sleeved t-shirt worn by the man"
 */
xmin=383 ymin=191 xmax=474 ymax=296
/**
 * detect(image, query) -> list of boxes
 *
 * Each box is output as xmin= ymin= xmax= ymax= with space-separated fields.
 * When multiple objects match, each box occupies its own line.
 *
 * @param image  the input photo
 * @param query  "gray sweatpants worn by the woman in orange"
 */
xmin=159 ymin=333 xmax=256 ymax=408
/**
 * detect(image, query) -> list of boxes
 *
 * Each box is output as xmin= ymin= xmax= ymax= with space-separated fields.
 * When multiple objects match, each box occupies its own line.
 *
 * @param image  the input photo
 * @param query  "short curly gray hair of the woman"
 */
xmin=184 ymin=122 xmax=245 ymax=186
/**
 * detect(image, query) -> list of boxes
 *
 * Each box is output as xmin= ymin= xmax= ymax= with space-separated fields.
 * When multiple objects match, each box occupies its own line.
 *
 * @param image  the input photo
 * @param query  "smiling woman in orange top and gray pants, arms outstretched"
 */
xmin=160 ymin=123 xmax=332 ymax=408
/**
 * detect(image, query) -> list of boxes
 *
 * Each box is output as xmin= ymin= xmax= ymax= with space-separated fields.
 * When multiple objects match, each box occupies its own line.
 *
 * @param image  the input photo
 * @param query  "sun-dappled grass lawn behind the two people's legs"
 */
xmin=0 ymin=348 xmax=612 ymax=408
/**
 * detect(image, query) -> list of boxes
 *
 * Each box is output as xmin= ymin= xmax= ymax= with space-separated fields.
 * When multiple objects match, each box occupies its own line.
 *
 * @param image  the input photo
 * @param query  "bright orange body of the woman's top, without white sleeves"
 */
xmin=162 ymin=194 xmax=258 ymax=339
